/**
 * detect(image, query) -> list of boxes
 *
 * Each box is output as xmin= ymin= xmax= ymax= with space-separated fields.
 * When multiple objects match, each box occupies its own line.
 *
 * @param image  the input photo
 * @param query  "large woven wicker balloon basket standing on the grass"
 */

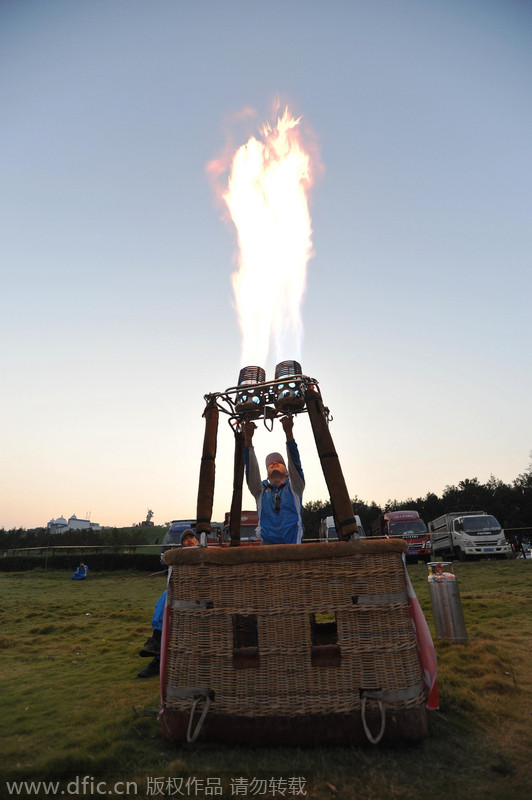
xmin=161 ymin=540 xmax=427 ymax=745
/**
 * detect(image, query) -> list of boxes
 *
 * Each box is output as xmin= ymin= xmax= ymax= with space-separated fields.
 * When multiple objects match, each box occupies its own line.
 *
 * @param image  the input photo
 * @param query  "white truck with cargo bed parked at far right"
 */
xmin=429 ymin=511 xmax=511 ymax=561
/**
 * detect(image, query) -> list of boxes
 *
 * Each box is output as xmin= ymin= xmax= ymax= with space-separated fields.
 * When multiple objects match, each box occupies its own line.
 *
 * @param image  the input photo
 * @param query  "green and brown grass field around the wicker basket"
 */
xmin=0 ymin=560 xmax=532 ymax=800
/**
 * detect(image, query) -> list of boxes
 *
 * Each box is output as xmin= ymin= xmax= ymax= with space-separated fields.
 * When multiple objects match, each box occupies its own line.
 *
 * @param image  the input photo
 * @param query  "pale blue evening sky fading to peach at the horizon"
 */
xmin=0 ymin=0 xmax=532 ymax=529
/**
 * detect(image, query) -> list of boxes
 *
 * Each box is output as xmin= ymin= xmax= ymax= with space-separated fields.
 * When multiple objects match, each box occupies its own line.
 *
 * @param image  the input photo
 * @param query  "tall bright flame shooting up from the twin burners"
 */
xmin=212 ymin=109 xmax=313 ymax=366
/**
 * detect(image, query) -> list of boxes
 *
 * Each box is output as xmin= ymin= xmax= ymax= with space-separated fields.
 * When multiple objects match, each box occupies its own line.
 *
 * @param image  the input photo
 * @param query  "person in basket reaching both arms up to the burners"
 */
xmin=244 ymin=417 xmax=305 ymax=544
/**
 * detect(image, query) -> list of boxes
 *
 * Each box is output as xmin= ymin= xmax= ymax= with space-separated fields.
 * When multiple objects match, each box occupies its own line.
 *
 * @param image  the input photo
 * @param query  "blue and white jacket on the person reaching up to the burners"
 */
xmin=244 ymin=440 xmax=305 ymax=544
